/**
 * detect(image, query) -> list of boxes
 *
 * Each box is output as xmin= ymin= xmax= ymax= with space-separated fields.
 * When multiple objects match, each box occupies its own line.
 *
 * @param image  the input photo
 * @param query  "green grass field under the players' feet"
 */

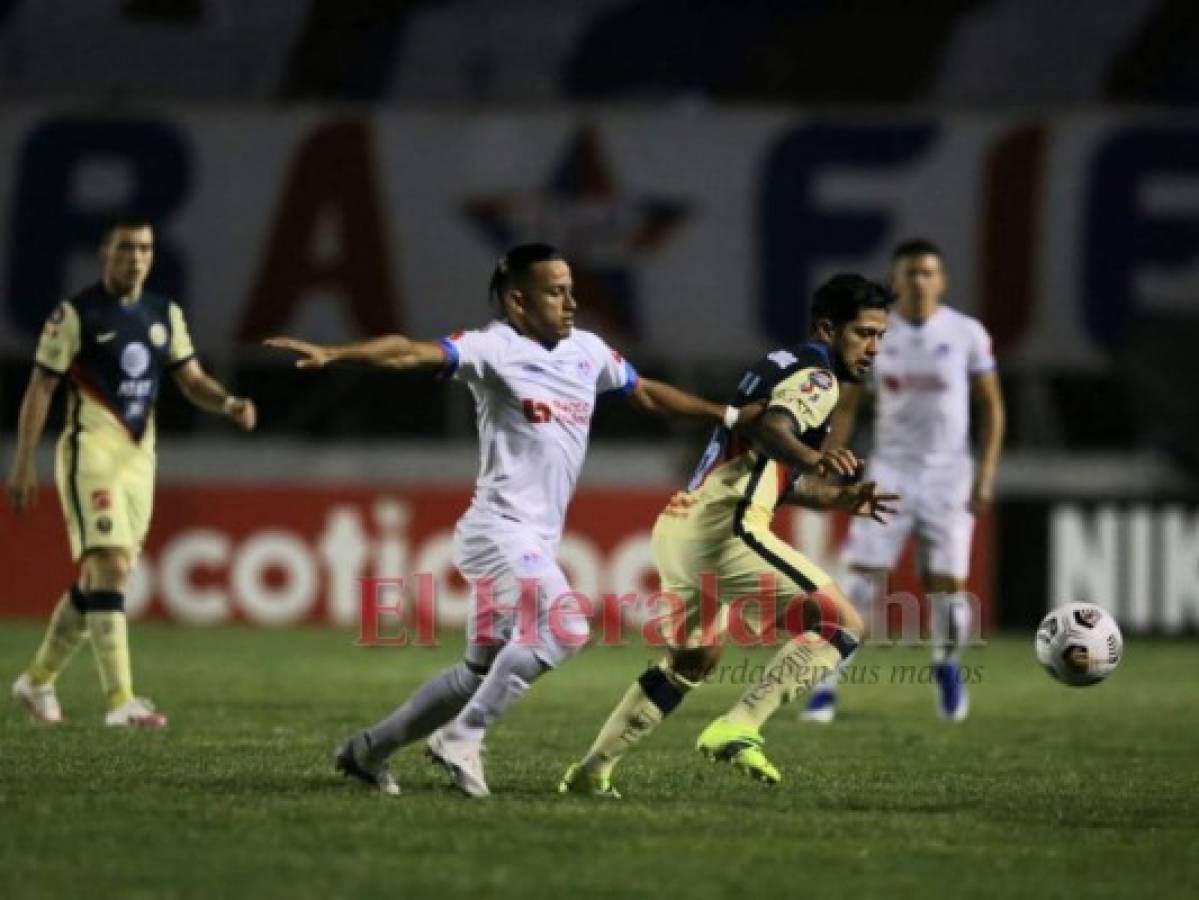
xmin=0 ymin=623 xmax=1199 ymax=900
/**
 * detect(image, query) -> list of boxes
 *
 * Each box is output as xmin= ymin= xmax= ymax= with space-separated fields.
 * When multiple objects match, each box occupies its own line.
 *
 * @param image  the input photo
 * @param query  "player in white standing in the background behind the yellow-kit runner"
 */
xmin=803 ymin=240 xmax=1004 ymax=721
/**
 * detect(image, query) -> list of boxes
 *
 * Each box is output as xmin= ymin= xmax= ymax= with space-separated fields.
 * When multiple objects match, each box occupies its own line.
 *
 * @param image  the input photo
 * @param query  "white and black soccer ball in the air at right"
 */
xmin=1036 ymin=603 xmax=1123 ymax=688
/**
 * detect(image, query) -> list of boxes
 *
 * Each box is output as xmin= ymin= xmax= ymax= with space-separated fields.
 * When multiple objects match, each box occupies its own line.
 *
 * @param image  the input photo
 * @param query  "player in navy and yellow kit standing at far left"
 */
xmin=8 ymin=217 xmax=255 ymax=729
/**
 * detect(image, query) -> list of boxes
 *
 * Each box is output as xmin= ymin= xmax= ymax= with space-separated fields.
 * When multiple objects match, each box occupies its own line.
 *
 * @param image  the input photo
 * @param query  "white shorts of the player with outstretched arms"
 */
xmin=453 ymin=511 xmax=590 ymax=669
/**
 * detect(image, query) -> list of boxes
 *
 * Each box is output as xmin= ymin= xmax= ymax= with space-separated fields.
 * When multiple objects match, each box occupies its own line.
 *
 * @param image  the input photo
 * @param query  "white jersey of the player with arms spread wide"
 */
xmin=439 ymin=321 xmax=638 ymax=544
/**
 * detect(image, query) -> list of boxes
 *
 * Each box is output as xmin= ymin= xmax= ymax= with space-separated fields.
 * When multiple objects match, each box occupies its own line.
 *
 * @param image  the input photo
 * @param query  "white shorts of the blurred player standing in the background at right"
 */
xmin=845 ymin=458 xmax=974 ymax=579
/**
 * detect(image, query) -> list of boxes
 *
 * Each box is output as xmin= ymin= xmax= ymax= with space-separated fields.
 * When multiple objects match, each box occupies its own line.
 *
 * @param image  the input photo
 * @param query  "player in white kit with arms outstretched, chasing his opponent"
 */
xmin=266 ymin=243 xmax=749 ymax=797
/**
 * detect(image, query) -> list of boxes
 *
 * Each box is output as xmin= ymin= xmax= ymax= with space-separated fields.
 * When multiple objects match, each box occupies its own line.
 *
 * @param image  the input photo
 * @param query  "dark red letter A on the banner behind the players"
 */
xmin=239 ymin=121 xmax=400 ymax=343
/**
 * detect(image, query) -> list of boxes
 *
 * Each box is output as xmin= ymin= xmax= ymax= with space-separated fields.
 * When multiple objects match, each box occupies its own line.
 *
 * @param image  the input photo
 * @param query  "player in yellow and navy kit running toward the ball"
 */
xmin=559 ymin=274 xmax=897 ymax=797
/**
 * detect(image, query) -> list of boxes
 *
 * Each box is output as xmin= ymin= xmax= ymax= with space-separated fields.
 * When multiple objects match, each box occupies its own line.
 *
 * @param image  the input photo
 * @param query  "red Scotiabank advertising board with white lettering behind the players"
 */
xmin=0 ymin=484 xmax=994 ymax=628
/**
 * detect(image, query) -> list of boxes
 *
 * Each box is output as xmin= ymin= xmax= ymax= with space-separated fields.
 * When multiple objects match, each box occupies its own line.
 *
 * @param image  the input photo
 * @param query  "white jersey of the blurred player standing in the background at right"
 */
xmin=872 ymin=306 xmax=995 ymax=465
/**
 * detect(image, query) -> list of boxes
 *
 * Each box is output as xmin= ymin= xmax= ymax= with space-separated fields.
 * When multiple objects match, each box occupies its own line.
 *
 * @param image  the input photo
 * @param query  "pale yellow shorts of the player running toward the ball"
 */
xmin=652 ymin=503 xmax=832 ymax=646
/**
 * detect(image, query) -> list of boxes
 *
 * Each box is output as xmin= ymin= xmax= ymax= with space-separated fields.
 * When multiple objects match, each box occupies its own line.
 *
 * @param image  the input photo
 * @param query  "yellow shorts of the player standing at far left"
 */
xmin=55 ymin=431 xmax=155 ymax=560
